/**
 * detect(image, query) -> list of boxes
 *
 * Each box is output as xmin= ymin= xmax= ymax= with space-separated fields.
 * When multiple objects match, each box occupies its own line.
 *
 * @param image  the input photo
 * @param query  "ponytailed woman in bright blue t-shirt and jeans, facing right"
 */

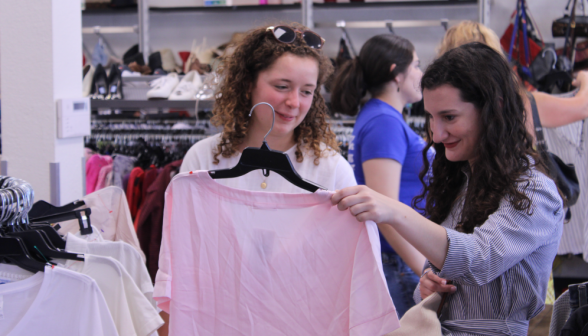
xmin=331 ymin=34 xmax=433 ymax=317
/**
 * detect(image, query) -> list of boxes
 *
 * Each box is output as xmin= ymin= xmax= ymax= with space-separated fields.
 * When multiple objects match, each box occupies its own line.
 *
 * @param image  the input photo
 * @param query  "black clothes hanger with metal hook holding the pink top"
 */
xmin=208 ymin=103 xmax=326 ymax=192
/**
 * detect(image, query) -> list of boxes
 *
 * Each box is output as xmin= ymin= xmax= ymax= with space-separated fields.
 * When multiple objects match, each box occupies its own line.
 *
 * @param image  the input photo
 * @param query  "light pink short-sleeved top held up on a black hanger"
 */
xmin=153 ymin=171 xmax=399 ymax=336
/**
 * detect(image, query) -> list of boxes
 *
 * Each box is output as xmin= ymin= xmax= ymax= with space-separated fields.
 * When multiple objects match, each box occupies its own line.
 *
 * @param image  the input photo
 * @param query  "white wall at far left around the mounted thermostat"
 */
xmin=0 ymin=0 xmax=83 ymax=203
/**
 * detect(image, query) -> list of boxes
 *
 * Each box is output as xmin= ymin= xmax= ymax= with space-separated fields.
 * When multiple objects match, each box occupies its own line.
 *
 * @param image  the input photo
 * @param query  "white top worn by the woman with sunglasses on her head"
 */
xmin=180 ymin=133 xmax=357 ymax=194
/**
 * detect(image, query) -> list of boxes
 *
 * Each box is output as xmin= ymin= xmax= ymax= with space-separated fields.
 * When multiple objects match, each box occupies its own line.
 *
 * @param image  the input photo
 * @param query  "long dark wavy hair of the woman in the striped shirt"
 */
xmin=413 ymin=43 xmax=546 ymax=233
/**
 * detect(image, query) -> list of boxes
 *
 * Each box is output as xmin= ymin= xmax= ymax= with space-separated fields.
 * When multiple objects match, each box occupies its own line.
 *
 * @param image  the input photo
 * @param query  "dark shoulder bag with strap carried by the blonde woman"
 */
xmin=528 ymin=94 xmax=580 ymax=213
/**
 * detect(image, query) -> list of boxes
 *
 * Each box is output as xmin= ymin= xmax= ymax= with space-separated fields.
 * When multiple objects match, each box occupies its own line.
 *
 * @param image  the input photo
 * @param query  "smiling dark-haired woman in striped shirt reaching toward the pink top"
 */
xmin=332 ymin=43 xmax=564 ymax=336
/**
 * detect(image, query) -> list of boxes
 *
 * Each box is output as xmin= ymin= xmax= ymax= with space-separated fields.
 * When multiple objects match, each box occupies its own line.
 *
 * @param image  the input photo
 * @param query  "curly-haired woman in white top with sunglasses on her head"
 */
xmin=180 ymin=24 xmax=356 ymax=193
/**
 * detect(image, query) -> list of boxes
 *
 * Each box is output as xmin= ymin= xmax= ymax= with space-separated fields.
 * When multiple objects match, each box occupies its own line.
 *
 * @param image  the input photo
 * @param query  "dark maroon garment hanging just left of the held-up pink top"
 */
xmin=137 ymin=160 xmax=182 ymax=282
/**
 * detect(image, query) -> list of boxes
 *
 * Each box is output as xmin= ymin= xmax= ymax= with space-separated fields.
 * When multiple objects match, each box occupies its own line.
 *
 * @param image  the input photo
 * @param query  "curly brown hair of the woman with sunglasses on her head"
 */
xmin=211 ymin=23 xmax=339 ymax=165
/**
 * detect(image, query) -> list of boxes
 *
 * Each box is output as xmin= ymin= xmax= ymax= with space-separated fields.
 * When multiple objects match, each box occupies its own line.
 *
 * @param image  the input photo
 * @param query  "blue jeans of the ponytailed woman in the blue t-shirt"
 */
xmin=382 ymin=252 xmax=420 ymax=318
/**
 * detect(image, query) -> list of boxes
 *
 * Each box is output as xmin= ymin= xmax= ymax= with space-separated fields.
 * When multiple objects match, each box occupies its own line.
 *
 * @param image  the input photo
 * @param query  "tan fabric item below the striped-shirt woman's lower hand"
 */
xmin=385 ymin=293 xmax=447 ymax=336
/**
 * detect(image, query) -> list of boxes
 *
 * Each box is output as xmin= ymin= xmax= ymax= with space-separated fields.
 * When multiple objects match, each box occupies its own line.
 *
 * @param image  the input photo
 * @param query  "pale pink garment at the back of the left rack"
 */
xmin=59 ymin=187 xmax=145 ymax=260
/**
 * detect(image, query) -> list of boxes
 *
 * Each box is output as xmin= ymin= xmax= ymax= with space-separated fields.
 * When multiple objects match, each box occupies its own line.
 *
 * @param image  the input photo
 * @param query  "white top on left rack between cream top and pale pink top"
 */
xmin=65 ymin=234 xmax=159 ymax=309
